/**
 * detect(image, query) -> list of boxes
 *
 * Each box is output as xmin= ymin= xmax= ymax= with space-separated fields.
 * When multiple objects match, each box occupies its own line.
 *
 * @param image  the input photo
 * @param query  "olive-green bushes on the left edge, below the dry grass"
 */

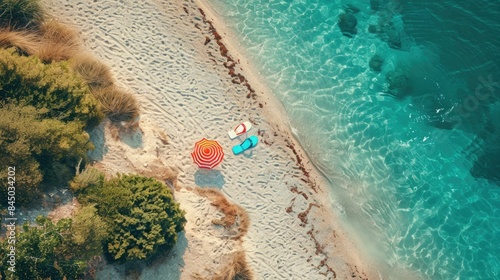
xmin=0 ymin=48 xmax=103 ymax=203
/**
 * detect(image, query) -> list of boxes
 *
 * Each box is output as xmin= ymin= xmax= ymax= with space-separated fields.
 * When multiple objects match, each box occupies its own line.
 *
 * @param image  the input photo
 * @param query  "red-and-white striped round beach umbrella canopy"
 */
xmin=191 ymin=138 xmax=224 ymax=169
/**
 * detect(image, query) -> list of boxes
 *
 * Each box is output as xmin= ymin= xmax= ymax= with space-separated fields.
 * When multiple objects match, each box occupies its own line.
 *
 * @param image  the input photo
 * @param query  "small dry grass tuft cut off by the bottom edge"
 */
xmin=212 ymin=251 xmax=255 ymax=280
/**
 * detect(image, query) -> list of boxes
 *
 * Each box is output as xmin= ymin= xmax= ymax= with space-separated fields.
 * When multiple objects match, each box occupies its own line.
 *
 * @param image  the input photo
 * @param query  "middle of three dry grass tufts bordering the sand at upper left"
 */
xmin=72 ymin=53 xmax=114 ymax=89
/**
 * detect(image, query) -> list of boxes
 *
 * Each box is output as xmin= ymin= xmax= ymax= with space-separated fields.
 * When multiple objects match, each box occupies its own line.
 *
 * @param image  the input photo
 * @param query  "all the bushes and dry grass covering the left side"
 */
xmin=0 ymin=0 xmax=182 ymax=279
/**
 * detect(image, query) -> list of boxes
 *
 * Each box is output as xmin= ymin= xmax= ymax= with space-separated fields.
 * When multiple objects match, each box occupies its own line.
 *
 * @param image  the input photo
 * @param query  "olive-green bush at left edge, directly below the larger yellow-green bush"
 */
xmin=0 ymin=104 xmax=93 ymax=203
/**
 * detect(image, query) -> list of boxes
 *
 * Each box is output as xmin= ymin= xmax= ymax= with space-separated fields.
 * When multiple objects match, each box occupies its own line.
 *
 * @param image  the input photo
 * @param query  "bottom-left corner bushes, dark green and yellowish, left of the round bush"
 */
xmin=0 ymin=206 xmax=108 ymax=280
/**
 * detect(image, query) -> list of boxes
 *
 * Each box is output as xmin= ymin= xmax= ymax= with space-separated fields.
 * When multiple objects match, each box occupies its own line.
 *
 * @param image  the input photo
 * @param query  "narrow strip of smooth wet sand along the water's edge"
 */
xmin=195 ymin=0 xmax=382 ymax=279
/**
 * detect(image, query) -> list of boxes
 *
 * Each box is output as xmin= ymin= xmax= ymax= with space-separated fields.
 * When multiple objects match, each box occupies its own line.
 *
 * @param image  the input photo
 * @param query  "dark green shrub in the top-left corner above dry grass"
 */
xmin=0 ymin=0 xmax=45 ymax=28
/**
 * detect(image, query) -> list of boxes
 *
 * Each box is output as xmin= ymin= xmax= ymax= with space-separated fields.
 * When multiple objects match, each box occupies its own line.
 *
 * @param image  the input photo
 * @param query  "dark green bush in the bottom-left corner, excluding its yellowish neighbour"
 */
xmin=0 ymin=216 xmax=86 ymax=280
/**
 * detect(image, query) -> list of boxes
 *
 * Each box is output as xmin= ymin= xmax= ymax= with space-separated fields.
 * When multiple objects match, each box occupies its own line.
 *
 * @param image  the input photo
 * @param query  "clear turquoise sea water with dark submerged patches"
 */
xmin=206 ymin=0 xmax=500 ymax=279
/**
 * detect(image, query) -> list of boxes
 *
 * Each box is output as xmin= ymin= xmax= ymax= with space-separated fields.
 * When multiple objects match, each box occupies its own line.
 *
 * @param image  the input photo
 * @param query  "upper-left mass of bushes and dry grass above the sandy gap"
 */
xmin=0 ymin=0 xmax=139 ymax=203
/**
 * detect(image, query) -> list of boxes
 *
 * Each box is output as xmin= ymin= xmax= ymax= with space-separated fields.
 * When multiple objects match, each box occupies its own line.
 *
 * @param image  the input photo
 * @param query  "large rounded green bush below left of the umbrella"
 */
xmin=79 ymin=175 xmax=186 ymax=261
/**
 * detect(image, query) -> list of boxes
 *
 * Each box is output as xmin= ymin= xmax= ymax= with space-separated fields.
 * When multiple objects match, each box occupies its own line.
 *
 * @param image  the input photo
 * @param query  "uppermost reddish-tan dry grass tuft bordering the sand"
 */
xmin=37 ymin=20 xmax=81 ymax=63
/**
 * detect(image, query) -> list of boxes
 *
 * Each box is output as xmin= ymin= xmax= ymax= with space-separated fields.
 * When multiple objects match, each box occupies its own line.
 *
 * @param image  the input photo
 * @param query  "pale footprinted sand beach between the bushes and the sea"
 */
xmin=45 ymin=0 xmax=379 ymax=279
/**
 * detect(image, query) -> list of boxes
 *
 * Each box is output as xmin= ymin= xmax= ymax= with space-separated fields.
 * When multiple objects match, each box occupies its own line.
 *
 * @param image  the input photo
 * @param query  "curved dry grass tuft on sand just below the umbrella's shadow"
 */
xmin=195 ymin=188 xmax=250 ymax=240
